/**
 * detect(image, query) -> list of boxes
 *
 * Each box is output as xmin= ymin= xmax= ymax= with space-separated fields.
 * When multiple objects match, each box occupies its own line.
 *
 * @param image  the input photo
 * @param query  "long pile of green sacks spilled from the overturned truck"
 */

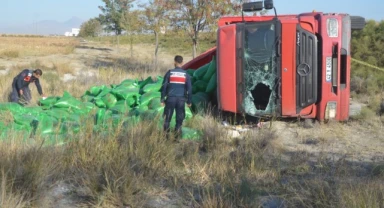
xmin=0 ymin=57 xmax=217 ymax=143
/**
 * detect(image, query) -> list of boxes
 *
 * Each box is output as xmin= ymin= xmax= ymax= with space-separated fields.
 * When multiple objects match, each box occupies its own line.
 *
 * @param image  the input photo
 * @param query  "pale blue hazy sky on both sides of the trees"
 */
xmin=0 ymin=0 xmax=384 ymax=26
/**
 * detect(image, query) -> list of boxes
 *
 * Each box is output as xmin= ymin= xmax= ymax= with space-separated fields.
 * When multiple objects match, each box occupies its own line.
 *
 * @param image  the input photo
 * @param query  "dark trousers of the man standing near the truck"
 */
xmin=164 ymin=97 xmax=186 ymax=137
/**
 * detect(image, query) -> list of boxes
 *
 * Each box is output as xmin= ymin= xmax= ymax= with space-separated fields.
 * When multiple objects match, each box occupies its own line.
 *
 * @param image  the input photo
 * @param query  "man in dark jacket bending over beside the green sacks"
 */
xmin=10 ymin=69 xmax=44 ymax=104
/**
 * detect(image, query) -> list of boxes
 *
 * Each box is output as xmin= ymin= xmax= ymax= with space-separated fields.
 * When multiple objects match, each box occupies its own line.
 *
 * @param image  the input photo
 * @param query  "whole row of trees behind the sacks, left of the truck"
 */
xmin=79 ymin=0 xmax=247 ymax=57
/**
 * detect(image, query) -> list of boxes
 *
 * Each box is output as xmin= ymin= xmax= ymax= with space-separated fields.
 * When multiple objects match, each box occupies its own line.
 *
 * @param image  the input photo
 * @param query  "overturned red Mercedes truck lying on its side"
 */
xmin=183 ymin=0 xmax=365 ymax=121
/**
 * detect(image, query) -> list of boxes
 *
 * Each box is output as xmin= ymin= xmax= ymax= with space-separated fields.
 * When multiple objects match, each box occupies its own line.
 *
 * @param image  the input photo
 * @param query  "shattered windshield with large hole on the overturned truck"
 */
xmin=243 ymin=23 xmax=277 ymax=116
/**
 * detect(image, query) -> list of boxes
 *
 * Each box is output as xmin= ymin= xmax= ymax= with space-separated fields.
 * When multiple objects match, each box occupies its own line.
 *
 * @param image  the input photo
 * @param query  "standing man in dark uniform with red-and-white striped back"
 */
xmin=161 ymin=55 xmax=192 ymax=139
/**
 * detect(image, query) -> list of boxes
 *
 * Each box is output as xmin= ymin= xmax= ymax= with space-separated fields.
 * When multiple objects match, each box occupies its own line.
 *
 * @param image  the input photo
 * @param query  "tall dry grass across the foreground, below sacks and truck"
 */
xmin=0 ymin=116 xmax=384 ymax=208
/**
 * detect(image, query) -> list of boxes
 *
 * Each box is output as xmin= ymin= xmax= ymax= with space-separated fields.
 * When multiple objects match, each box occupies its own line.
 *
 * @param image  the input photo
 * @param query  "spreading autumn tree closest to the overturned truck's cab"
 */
xmin=163 ymin=0 xmax=241 ymax=57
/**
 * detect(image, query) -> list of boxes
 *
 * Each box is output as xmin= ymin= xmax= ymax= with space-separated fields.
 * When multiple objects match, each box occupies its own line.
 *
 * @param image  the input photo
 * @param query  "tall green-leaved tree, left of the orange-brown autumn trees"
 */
xmin=99 ymin=0 xmax=135 ymax=35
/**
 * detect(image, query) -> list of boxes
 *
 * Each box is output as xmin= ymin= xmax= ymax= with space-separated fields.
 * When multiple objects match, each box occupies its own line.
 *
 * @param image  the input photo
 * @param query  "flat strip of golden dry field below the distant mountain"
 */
xmin=0 ymin=36 xmax=78 ymax=58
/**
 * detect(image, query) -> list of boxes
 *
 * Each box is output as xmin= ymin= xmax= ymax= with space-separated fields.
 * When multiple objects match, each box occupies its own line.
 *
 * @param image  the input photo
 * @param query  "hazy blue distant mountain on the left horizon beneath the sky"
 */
xmin=0 ymin=17 xmax=84 ymax=35
